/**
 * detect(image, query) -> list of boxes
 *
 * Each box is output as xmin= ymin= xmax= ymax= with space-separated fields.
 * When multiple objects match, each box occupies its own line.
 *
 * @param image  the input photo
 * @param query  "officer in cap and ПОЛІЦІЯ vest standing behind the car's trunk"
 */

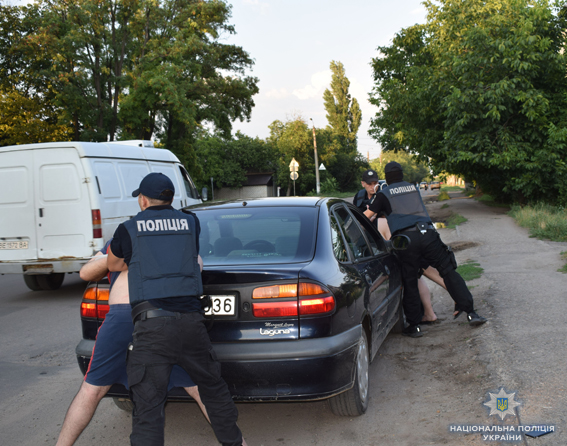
xmin=108 ymin=173 xmax=243 ymax=446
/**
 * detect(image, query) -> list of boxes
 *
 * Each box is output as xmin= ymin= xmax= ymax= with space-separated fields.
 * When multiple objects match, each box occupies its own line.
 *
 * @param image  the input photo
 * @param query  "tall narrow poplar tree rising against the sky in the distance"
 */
xmin=318 ymin=61 xmax=364 ymax=190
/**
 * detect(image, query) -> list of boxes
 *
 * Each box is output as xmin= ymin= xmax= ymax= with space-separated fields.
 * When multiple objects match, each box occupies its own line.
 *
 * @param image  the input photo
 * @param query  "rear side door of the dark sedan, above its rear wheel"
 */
xmin=334 ymin=205 xmax=389 ymax=356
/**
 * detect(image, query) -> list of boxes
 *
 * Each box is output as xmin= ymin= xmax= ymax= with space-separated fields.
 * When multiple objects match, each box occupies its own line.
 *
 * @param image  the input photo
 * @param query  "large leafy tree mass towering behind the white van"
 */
xmin=0 ymin=0 xmax=258 ymax=176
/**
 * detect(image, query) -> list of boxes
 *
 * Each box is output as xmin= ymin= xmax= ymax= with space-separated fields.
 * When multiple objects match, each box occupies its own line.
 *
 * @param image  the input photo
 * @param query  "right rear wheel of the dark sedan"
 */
xmin=329 ymin=329 xmax=370 ymax=417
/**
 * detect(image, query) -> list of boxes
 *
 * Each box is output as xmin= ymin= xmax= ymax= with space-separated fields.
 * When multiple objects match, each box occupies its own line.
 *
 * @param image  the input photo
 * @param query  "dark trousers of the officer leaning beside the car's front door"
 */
xmin=397 ymin=229 xmax=474 ymax=325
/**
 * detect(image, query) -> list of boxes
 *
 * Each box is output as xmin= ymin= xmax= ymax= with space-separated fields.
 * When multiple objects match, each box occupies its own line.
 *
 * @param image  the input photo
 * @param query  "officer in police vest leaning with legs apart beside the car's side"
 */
xmin=365 ymin=162 xmax=486 ymax=337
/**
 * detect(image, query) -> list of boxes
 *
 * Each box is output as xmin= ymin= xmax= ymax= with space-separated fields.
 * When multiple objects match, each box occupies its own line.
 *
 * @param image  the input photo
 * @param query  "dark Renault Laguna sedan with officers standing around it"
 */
xmin=77 ymin=198 xmax=404 ymax=416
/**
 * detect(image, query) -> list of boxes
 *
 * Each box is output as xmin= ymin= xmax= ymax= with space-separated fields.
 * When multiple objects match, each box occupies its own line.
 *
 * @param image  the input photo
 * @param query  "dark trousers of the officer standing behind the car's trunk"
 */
xmin=127 ymin=313 xmax=242 ymax=446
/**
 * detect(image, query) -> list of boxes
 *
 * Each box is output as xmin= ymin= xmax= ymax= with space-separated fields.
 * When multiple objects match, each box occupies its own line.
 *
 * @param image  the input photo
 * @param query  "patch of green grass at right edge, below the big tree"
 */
xmin=508 ymin=203 xmax=567 ymax=242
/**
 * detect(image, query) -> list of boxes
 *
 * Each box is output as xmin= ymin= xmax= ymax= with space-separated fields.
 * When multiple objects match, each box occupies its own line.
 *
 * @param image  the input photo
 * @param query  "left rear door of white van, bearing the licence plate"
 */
xmin=0 ymin=150 xmax=37 ymax=261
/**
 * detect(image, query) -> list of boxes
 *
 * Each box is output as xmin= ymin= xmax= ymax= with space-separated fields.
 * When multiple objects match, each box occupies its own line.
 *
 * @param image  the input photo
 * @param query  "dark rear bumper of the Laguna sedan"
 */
xmin=76 ymin=326 xmax=362 ymax=401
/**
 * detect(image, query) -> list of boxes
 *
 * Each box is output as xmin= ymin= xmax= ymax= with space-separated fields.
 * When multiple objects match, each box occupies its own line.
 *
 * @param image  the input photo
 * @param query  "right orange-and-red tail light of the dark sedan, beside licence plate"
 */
xmin=252 ymin=282 xmax=336 ymax=318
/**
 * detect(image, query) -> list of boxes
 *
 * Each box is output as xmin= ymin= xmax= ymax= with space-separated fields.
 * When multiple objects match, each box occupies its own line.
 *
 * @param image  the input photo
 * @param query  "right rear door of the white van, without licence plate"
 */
xmin=33 ymin=148 xmax=93 ymax=259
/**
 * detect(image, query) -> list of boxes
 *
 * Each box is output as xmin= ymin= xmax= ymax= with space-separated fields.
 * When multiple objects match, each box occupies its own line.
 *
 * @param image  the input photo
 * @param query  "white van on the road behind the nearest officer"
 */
xmin=0 ymin=141 xmax=201 ymax=290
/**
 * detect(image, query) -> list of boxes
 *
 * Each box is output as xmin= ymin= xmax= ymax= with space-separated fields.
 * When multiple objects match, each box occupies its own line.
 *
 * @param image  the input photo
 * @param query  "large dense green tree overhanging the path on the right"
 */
xmin=371 ymin=0 xmax=567 ymax=202
